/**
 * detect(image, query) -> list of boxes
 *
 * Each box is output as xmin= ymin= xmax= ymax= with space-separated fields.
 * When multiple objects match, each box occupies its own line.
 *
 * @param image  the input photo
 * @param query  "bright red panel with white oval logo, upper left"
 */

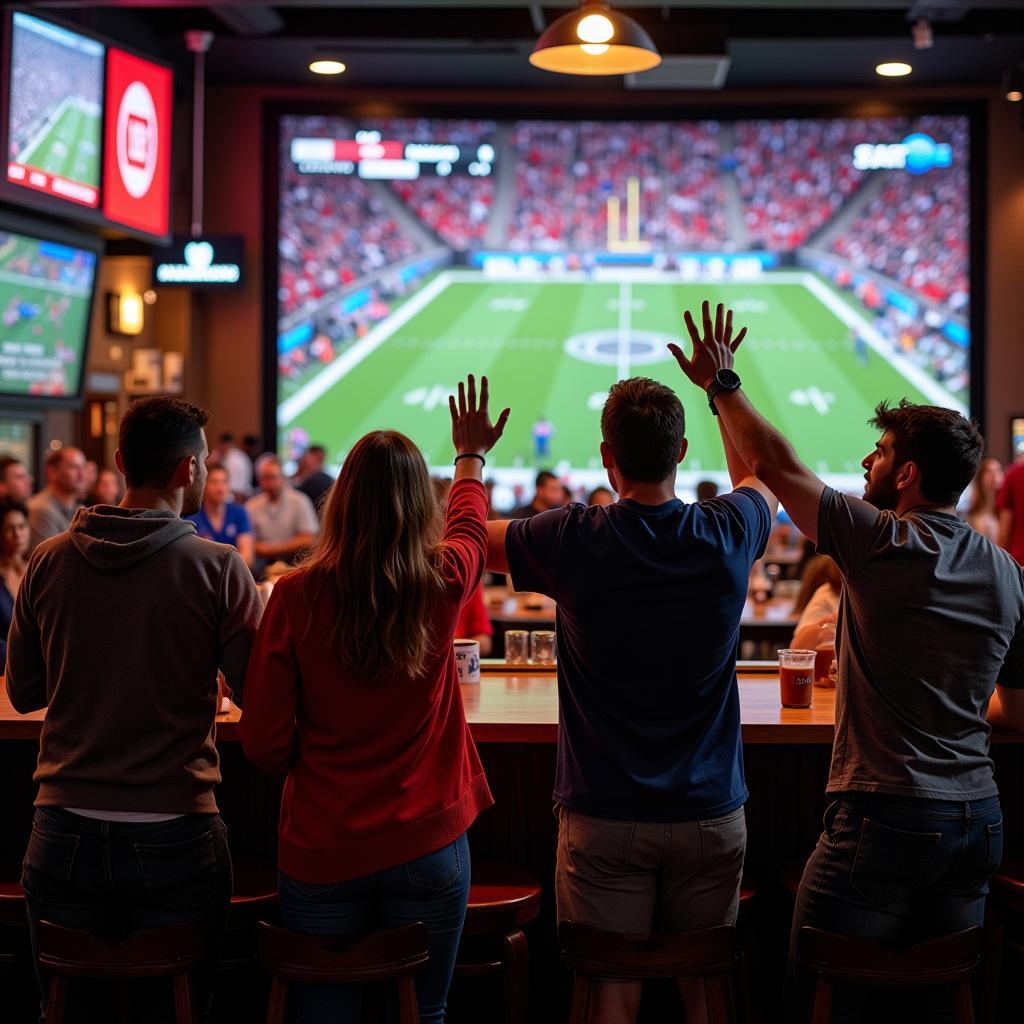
xmin=103 ymin=47 xmax=173 ymax=236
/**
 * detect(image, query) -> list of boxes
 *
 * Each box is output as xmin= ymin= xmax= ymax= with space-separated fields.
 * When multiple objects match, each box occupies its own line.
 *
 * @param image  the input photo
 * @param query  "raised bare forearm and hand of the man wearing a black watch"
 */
xmin=669 ymin=302 xmax=825 ymax=542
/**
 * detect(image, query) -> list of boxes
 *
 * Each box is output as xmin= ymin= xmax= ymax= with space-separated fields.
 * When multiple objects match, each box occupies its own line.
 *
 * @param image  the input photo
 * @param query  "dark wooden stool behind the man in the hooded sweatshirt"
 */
xmin=39 ymin=921 xmax=206 ymax=1024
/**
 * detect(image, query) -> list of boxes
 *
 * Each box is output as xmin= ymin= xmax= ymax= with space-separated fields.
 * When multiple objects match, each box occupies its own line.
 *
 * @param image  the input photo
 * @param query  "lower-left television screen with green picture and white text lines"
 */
xmin=0 ymin=218 xmax=98 ymax=404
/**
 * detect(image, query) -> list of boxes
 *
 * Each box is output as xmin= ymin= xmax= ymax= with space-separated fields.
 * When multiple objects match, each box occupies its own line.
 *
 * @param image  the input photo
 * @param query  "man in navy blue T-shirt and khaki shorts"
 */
xmin=487 ymin=306 xmax=777 ymax=1021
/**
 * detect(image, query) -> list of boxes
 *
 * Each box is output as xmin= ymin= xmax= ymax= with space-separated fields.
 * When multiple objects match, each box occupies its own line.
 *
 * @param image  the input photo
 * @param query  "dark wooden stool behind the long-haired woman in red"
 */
xmin=258 ymin=921 xmax=430 ymax=1024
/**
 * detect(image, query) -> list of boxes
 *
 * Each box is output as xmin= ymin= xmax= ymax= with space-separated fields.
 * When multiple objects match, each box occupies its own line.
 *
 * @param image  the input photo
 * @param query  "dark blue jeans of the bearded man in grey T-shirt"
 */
xmin=786 ymin=793 xmax=1002 ymax=1024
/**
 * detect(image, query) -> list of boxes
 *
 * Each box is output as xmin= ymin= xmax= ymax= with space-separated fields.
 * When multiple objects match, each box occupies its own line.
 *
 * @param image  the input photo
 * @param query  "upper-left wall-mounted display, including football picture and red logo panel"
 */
xmin=0 ymin=8 xmax=173 ymax=242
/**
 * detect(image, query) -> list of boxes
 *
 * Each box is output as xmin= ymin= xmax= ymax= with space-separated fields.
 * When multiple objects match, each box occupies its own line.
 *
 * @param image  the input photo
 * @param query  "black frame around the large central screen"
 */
xmin=261 ymin=92 xmax=988 ymax=450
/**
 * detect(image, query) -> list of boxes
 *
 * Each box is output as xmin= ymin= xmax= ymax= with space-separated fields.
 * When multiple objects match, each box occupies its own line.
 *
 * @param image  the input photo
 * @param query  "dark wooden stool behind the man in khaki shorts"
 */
xmin=558 ymin=921 xmax=737 ymax=1024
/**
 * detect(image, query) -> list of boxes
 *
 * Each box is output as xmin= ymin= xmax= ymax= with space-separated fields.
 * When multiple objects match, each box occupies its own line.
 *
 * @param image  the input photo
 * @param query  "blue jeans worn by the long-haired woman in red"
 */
xmin=279 ymin=836 xmax=470 ymax=1024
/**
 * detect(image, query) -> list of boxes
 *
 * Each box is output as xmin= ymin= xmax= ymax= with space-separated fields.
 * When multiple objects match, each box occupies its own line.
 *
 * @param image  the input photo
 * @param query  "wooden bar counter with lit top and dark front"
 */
xmin=0 ymin=663 xmax=1024 ymax=1024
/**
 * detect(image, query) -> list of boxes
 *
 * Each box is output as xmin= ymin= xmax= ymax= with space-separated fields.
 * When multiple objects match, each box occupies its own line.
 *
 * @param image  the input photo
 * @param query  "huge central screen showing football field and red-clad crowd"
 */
xmin=271 ymin=114 xmax=971 ymax=490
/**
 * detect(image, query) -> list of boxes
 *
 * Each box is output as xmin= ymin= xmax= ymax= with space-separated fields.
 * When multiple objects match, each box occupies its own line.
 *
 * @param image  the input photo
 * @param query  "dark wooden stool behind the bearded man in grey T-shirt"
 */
xmin=797 ymin=926 xmax=982 ymax=1024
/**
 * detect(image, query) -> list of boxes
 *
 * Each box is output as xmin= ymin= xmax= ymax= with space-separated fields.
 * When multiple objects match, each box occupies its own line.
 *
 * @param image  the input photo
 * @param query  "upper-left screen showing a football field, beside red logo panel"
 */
xmin=7 ymin=11 xmax=103 ymax=207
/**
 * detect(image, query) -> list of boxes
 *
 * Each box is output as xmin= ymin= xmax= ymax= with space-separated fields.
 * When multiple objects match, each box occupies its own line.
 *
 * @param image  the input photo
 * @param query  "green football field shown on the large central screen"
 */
xmin=279 ymin=271 xmax=952 ymax=474
